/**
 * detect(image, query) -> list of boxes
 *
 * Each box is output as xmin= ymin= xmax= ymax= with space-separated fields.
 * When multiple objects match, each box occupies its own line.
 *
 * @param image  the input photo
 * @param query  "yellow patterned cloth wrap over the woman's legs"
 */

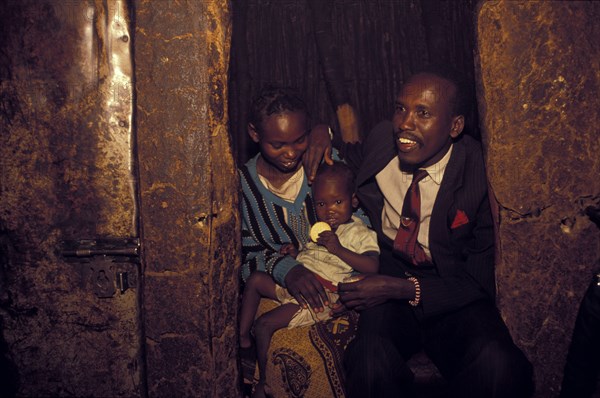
xmin=255 ymin=299 xmax=358 ymax=398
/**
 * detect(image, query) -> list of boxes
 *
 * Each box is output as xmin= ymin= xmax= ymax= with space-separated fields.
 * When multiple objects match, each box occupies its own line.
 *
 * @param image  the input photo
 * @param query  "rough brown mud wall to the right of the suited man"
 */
xmin=477 ymin=1 xmax=600 ymax=397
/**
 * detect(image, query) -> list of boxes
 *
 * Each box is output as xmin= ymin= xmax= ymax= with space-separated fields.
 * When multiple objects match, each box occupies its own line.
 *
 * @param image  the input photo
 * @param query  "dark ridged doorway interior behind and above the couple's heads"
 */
xmin=229 ymin=0 xmax=479 ymax=164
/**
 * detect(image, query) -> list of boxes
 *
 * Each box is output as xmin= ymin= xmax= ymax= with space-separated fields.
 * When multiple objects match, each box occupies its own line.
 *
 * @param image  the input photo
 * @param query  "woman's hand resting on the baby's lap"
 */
xmin=285 ymin=265 xmax=329 ymax=312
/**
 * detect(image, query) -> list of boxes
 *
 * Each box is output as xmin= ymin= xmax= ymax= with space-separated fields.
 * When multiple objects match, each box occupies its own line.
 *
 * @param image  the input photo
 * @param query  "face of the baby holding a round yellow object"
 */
xmin=312 ymin=176 xmax=357 ymax=231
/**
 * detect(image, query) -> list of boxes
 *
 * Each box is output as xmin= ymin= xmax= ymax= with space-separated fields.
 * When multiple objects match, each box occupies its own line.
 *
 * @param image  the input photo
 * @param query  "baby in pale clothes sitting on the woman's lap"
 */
xmin=240 ymin=162 xmax=379 ymax=397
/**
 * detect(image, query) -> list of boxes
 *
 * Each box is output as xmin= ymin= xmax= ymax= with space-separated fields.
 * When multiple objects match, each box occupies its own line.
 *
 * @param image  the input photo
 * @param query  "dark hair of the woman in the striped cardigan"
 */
xmin=248 ymin=85 xmax=309 ymax=132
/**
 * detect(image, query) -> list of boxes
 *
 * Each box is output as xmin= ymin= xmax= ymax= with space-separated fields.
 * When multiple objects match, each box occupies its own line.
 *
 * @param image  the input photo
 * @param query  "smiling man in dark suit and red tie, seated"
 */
xmin=290 ymin=68 xmax=534 ymax=398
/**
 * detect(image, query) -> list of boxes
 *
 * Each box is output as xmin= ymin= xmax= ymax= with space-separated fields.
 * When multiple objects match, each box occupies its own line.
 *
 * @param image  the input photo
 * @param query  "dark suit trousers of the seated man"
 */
xmin=344 ymin=294 xmax=534 ymax=398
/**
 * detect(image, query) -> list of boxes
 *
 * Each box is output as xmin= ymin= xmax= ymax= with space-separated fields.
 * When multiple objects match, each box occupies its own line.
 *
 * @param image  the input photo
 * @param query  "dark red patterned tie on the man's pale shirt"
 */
xmin=394 ymin=169 xmax=429 ymax=265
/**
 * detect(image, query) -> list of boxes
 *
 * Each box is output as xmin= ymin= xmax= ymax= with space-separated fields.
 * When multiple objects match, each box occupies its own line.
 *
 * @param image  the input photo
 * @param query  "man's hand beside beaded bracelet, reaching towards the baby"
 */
xmin=338 ymin=274 xmax=414 ymax=311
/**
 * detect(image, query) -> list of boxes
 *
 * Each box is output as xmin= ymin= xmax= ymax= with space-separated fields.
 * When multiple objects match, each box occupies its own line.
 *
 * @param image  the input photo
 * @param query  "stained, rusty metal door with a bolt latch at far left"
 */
xmin=0 ymin=0 xmax=142 ymax=397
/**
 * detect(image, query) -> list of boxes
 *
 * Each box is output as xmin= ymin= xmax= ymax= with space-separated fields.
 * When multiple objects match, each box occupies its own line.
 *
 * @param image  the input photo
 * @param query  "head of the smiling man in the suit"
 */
xmin=392 ymin=73 xmax=464 ymax=168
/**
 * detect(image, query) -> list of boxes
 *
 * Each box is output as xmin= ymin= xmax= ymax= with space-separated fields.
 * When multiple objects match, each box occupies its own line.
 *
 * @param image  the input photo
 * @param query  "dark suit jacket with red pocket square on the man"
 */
xmin=341 ymin=122 xmax=495 ymax=317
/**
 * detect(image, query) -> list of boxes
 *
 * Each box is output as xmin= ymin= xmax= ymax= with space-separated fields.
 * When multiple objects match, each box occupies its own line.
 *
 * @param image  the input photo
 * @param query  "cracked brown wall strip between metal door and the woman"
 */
xmin=135 ymin=0 xmax=240 ymax=397
